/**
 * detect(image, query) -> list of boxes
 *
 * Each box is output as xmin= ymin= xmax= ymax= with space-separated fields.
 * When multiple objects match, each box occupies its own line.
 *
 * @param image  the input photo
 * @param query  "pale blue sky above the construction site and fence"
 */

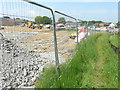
xmin=0 ymin=0 xmax=119 ymax=22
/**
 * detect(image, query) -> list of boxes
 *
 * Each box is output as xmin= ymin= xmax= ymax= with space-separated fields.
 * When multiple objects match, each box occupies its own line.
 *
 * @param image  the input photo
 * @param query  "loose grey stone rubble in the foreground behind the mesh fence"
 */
xmin=0 ymin=32 xmax=65 ymax=89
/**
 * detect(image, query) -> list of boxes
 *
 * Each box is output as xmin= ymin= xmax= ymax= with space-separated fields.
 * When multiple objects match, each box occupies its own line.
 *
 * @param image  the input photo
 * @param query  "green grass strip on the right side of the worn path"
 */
xmin=103 ymin=35 xmax=118 ymax=88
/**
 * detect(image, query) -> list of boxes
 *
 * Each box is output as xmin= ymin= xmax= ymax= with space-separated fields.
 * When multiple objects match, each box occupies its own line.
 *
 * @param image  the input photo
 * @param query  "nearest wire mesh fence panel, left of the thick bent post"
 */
xmin=0 ymin=0 xmax=64 ymax=88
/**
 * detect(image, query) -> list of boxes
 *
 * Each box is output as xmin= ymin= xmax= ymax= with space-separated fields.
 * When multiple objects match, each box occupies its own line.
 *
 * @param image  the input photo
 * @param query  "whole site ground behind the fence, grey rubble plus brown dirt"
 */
xmin=0 ymin=20 xmax=76 ymax=88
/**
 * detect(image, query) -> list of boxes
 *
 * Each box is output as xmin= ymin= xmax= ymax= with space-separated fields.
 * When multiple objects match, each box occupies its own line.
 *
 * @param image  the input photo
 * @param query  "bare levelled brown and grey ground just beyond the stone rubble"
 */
xmin=0 ymin=26 xmax=76 ymax=57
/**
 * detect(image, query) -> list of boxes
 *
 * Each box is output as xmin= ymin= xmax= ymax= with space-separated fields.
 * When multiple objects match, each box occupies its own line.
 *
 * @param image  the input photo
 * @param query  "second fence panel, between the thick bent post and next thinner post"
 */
xmin=55 ymin=11 xmax=77 ymax=62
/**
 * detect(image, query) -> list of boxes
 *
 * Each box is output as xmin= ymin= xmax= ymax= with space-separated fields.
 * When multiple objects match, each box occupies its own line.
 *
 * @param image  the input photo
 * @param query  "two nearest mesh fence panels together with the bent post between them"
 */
xmin=0 ymin=0 xmax=80 ymax=88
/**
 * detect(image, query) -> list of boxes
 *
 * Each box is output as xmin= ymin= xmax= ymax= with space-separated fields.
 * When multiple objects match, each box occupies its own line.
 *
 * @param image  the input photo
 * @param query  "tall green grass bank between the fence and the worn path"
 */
xmin=36 ymin=36 xmax=97 ymax=88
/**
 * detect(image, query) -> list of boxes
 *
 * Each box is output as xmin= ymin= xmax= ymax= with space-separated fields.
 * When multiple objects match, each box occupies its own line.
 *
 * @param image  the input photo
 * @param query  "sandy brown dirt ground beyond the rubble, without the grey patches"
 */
xmin=0 ymin=26 xmax=76 ymax=59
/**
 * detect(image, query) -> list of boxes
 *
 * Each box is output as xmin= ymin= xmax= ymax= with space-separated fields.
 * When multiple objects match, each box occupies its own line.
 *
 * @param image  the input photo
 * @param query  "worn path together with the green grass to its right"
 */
xmin=94 ymin=34 xmax=118 ymax=88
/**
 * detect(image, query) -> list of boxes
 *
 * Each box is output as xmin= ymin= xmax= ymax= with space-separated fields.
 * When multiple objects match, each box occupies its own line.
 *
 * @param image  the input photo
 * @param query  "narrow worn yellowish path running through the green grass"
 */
xmin=92 ymin=36 xmax=105 ymax=88
